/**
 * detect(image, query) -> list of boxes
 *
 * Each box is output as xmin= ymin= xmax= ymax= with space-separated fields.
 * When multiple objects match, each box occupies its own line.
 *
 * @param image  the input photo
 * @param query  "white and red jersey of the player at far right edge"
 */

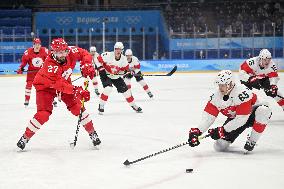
xmin=240 ymin=57 xmax=279 ymax=85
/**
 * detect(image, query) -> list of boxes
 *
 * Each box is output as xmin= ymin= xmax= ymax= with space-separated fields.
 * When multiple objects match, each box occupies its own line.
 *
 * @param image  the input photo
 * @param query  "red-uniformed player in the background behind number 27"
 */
xmin=17 ymin=38 xmax=52 ymax=107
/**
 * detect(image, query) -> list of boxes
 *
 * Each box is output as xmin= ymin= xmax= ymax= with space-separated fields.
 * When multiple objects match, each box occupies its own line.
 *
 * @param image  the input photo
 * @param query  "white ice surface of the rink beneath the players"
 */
xmin=0 ymin=73 xmax=284 ymax=189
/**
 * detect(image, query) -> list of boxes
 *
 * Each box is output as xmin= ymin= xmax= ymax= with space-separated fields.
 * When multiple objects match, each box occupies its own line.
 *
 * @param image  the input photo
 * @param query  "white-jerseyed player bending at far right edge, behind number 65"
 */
xmin=240 ymin=49 xmax=284 ymax=110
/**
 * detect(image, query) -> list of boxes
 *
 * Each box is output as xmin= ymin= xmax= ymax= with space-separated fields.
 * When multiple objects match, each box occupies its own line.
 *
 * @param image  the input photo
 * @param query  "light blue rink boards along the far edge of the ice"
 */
xmin=0 ymin=58 xmax=284 ymax=75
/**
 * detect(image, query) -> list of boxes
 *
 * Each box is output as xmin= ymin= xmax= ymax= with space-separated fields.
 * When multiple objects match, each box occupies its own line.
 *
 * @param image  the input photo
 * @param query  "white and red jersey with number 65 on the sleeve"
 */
xmin=198 ymin=84 xmax=259 ymax=133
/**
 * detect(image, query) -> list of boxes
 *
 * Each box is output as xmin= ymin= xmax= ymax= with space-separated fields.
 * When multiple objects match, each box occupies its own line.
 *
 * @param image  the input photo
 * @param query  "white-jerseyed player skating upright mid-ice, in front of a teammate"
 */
xmin=97 ymin=42 xmax=142 ymax=114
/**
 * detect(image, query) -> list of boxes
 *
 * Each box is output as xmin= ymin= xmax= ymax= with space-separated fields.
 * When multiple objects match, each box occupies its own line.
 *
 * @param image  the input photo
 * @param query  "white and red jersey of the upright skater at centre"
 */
xmin=97 ymin=52 xmax=129 ymax=79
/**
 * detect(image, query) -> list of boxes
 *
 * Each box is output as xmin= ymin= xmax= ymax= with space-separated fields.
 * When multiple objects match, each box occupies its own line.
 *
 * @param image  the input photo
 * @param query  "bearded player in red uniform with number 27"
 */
xmin=17 ymin=38 xmax=101 ymax=150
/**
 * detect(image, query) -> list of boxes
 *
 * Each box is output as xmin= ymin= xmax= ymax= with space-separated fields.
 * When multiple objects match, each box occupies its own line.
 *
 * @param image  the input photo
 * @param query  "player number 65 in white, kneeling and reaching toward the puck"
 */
xmin=188 ymin=70 xmax=271 ymax=151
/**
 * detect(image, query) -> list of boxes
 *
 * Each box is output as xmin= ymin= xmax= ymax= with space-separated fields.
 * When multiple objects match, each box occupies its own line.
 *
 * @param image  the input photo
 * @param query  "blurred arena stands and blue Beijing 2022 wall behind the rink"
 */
xmin=0 ymin=0 xmax=284 ymax=67
